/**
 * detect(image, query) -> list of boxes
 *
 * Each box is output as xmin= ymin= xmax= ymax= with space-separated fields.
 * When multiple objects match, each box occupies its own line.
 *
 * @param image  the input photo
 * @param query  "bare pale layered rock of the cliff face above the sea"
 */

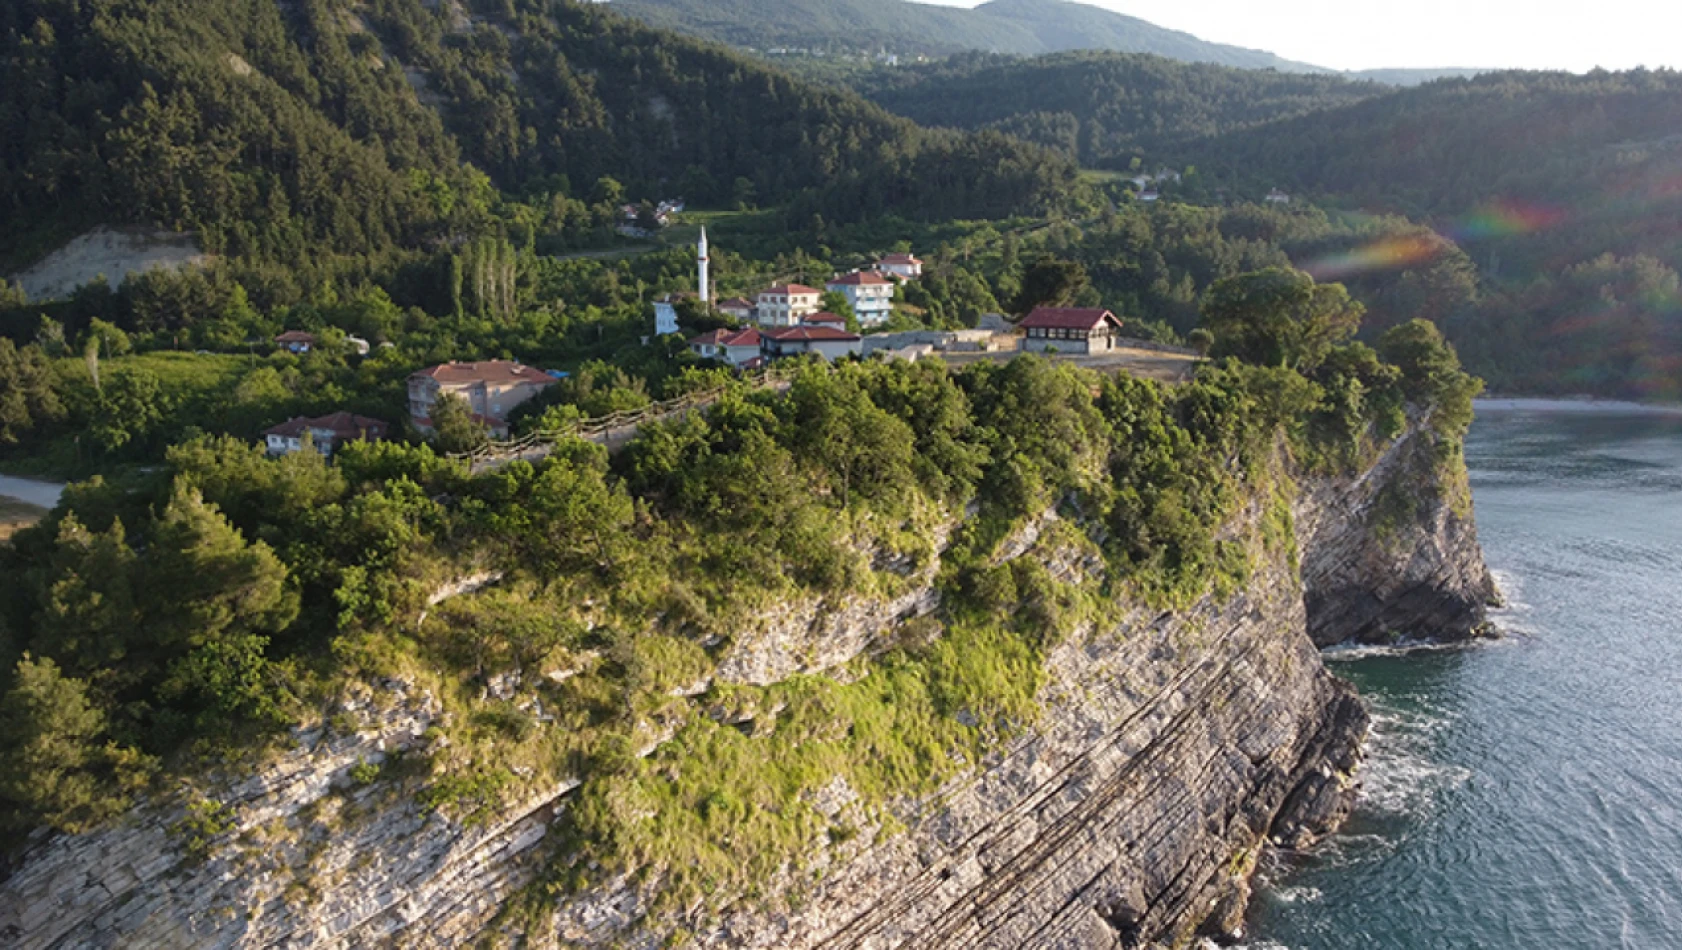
xmin=0 ymin=422 xmax=1492 ymax=948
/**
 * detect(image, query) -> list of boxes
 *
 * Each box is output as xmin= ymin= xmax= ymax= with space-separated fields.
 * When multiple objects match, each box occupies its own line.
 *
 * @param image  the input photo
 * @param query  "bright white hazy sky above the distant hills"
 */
xmin=932 ymin=0 xmax=1682 ymax=72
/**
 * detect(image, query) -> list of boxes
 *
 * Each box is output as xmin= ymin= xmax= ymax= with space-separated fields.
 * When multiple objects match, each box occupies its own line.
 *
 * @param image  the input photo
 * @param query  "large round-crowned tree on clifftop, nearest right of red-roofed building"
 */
xmin=1203 ymin=267 xmax=1364 ymax=373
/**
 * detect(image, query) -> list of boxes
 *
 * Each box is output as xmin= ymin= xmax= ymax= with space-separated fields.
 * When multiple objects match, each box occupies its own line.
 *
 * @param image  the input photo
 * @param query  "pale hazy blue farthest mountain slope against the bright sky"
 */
xmin=598 ymin=0 xmax=1324 ymax=72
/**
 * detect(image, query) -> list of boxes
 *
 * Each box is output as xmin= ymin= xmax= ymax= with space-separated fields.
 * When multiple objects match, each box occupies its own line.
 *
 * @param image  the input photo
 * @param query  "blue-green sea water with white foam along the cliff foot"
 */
xmin=1250 ymin=404 xmax=1682 ymax=950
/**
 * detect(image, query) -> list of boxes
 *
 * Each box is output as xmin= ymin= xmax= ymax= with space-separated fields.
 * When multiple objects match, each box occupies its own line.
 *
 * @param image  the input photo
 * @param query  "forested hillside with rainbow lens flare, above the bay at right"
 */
xmin=1184 ymin=71 xmax=1682 ymax=398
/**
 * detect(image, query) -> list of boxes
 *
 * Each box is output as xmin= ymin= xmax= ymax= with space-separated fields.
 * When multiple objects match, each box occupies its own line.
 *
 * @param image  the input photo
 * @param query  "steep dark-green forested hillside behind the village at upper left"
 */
xmin=0 ymin=0 xmax=1073 ymax=270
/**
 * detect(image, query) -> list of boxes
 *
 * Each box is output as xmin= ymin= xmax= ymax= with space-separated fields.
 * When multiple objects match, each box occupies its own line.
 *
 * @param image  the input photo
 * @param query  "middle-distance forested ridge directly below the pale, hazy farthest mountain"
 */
xmin=853 ymin=52 xmax=1389 ymax=168
